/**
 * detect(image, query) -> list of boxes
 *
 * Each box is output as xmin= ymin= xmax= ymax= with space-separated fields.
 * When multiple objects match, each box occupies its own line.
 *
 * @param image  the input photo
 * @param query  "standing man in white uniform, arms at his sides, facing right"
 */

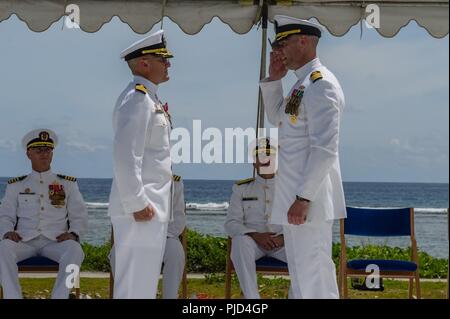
xmin=109 ymin=30 xmax=173 ymax=299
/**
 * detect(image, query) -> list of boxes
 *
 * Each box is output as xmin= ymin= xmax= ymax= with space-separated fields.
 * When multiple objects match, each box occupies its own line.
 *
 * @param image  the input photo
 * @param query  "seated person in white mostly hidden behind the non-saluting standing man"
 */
xmin=163 ymin=175 xmax=186 ymax=299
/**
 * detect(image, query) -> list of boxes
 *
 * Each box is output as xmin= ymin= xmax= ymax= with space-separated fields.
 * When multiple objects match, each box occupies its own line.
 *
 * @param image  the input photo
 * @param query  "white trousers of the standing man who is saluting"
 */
xmin=283 ymin=221 xmax=339 ymax=299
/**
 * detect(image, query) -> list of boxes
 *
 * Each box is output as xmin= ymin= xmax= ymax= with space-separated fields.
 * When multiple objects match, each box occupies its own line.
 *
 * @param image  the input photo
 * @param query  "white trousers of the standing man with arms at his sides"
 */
xmin=111 ymin=215 xmax=167 ymax=299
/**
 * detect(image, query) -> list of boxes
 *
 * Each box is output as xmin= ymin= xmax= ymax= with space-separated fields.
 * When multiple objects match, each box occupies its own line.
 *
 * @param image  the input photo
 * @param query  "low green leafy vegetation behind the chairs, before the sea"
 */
xmin=81 ymin=230 xmax=448 ymax=279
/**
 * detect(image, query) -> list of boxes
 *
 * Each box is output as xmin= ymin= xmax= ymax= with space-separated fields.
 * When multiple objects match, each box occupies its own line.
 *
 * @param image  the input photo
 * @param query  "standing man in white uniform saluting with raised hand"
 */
xmin=260 ymin=16 xmax=346 ymax=298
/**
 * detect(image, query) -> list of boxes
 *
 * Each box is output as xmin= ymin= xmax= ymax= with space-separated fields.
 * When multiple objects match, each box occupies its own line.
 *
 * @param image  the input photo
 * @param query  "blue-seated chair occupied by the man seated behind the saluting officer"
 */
xmin=225 ymin=237 xmax=289 ymax=299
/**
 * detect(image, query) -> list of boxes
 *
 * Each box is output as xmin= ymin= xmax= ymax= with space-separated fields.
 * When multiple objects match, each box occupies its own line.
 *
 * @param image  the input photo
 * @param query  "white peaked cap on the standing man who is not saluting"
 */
xmin=120 ymin=30 xmax=173 ymax=61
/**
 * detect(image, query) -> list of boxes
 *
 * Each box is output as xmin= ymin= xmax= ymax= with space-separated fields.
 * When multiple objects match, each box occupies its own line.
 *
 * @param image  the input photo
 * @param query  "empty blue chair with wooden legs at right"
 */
xmin=339 ymin=207 xmax=420 ymax=299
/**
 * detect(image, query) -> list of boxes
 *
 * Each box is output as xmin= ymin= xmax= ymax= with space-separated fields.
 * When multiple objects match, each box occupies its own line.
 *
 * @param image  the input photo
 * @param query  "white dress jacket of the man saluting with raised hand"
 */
xmin=260 ymin=58 xmax=346 ymax=225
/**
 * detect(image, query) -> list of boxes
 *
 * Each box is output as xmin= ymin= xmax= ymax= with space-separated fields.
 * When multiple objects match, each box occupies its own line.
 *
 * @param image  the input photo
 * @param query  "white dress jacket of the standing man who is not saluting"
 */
xmin=109 ymin=76 xmax=172 ymax=222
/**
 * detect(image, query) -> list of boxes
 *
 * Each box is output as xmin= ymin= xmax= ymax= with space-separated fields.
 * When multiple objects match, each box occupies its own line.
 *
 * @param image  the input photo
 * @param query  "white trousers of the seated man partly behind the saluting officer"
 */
xmin=231 ymin=235 xmax=287 ymax=299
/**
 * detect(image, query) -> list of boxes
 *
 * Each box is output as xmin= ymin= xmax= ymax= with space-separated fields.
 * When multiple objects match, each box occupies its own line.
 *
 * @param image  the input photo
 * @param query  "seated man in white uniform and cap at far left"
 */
xmin=0 ymin=129 xmax=87 ymax=299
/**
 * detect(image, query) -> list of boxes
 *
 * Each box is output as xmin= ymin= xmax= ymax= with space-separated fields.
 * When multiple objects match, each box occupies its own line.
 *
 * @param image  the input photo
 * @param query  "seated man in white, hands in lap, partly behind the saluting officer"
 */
xmin=225 ymin=139 xmax=286 ymax=299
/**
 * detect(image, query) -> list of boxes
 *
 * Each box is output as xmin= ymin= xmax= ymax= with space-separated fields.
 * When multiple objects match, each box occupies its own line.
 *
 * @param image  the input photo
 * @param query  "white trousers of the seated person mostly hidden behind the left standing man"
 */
xmin=163 ymin=237 xmax=185 ymax=299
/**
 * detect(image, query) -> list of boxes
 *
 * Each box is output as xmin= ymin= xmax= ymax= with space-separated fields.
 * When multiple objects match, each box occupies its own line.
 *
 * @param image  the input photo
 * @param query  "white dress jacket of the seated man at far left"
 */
xmin=0 ymin=171 xmax=88 ymax=242
